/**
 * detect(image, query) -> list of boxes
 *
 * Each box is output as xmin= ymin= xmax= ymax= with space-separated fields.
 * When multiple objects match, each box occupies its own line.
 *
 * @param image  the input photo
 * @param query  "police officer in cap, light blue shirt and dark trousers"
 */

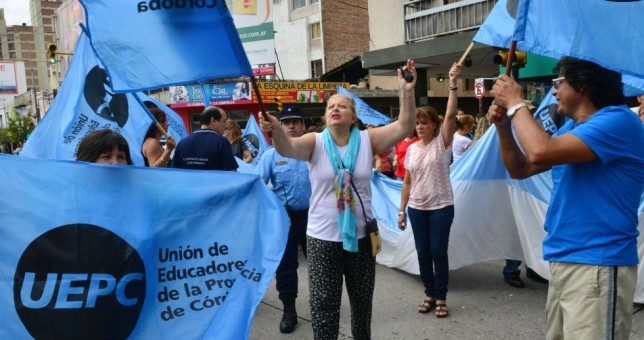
xmin=256 ymin=106 xmax=311 ymax=333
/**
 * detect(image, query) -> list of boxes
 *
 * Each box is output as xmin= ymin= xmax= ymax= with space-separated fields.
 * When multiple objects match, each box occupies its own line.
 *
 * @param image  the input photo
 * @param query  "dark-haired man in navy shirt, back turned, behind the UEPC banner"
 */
xmin=172 ymin=106 xmax=237 ymax=171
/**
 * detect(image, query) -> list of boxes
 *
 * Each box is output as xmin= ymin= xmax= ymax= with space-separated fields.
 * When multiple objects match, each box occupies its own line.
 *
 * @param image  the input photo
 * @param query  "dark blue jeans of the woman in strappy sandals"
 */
xmin=408 ymin=205 xmax=454 ymax=300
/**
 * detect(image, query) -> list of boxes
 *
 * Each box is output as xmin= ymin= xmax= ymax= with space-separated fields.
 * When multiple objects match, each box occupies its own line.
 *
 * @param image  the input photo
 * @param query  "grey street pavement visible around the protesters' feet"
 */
xmin=250 ymin=254 xmax=644 ymax=340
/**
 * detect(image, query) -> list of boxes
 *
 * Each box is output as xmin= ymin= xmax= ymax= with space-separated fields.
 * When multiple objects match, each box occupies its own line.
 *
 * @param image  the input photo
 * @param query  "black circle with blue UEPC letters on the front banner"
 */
xmin=13 ymin=224 xmax=145 ymax=339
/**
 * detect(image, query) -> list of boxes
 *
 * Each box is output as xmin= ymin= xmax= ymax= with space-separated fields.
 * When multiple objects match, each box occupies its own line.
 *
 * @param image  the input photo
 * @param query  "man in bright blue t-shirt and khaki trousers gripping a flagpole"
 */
xmin=488 ymin=57 xmax=644 ymax=339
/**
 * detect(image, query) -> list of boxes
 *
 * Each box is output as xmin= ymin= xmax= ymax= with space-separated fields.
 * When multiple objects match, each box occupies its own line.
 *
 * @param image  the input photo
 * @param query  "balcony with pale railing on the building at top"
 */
xmin=403 ymin=0 xmax=498 ymax=43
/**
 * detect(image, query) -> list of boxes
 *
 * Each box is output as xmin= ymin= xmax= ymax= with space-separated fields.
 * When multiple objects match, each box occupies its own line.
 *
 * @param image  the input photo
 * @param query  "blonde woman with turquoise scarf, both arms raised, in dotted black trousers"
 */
xmin=261 ymin=60 xmax=416 ymax=339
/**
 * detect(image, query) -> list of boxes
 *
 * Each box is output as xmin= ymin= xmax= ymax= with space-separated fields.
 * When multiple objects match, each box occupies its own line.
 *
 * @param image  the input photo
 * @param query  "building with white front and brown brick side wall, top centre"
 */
xmin=273 ymin=0 xmax=369 ymax=80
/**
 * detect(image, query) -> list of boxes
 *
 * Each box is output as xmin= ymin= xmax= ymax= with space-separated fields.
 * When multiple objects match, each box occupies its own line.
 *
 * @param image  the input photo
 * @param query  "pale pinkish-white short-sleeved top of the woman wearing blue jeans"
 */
xmin=405 ymin=135 xmax=454 ymax=210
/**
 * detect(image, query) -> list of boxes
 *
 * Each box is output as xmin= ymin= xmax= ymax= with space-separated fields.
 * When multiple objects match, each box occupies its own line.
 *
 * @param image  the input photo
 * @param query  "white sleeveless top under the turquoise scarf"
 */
xmin=306 ymin=130 xmax=373 ymax=242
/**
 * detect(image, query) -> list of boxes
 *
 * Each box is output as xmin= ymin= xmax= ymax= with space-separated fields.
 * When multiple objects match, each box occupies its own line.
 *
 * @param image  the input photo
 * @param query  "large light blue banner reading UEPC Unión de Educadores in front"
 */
xmin=0 ymin=155 xmax=289 ymax=340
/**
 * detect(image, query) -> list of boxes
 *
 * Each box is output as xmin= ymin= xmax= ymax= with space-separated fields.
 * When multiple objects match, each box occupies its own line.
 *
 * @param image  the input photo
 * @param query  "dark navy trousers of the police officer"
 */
xmin=275 ymin=210 xmax=308 ymax=301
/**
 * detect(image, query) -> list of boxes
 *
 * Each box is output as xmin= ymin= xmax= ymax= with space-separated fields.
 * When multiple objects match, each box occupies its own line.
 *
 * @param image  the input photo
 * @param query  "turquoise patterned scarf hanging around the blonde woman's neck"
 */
xmin=322 ymin=127 xmax=360 ymax=253
